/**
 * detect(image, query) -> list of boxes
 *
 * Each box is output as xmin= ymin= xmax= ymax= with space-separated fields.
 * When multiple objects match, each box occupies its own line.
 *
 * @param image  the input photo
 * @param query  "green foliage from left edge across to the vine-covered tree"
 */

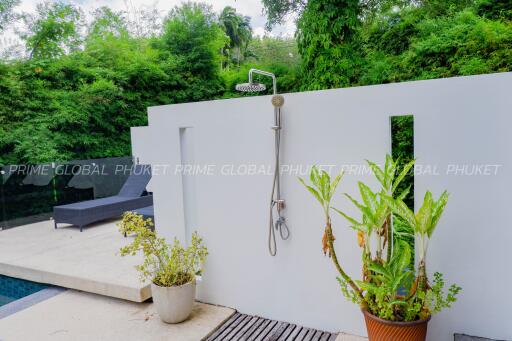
xmin=0 ymin=2 xmax=298 ymax=164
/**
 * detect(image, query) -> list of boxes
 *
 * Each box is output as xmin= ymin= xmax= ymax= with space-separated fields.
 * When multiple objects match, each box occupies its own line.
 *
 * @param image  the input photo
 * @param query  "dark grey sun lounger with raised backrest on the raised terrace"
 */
xmin=53 ymin=165 xmax=153 ymax=232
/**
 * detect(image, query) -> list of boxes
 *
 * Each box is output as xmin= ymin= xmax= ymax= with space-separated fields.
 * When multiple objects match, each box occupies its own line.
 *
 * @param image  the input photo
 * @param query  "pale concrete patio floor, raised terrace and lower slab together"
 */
xmin=0 ymin=220 xmax=365 ymax=341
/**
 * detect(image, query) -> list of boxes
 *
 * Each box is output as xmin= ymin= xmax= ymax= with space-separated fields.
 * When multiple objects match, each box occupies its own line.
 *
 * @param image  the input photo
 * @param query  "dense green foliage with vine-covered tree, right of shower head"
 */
xmin=264 ymin=0 xmax=512 ymax=90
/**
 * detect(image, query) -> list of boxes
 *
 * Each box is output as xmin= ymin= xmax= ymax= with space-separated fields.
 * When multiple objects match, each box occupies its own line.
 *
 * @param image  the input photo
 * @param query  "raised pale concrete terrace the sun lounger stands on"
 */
xmin=0 ymin=220 xmax=151 ymax=302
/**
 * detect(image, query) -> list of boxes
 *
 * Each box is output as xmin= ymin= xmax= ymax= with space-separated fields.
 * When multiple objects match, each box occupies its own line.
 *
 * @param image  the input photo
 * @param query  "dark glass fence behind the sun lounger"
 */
xmin=0 ymin=157 xmax=133 ymax=229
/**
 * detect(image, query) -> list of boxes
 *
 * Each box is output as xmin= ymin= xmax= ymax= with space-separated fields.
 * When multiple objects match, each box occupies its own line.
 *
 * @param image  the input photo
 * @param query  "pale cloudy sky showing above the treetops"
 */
xmin=0 ymin=0 xmax=295 ymax=50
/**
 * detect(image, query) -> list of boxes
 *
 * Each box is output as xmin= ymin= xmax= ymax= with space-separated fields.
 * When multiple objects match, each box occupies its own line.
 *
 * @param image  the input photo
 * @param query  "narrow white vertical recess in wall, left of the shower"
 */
xmin=180 ymin=127 xmax=196 ymax=244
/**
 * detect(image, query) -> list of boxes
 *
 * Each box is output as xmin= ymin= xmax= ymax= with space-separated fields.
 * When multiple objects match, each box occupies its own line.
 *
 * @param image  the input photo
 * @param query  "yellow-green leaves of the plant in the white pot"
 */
xmin=119 ymin=212 xmax=208 ymax=287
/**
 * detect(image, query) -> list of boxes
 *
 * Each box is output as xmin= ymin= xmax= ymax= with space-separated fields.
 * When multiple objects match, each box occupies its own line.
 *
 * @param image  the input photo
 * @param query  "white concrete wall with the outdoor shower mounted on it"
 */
xmin=132 ymin=73 xmax=512 ymax=341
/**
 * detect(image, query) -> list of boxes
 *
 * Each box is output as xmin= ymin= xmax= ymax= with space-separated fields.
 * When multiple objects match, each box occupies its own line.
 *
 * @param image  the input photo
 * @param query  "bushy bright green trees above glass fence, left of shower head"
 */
xmin=0 ymin=4 xmax=227 ymax=164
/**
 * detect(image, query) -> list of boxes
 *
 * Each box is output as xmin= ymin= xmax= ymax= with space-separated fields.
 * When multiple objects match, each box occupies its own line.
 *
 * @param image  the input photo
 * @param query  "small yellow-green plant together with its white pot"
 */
xmin=119 ymin=212 xmax=208 ymax=323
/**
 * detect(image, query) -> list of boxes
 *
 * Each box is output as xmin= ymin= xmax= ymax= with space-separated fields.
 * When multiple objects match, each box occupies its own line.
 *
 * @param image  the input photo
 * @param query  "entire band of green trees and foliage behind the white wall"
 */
xmin=0 ymin=0 xmax=512 ymax=165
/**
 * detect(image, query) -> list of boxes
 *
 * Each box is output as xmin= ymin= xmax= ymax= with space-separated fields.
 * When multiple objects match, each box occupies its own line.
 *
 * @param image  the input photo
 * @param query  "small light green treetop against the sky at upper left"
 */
xmin=21 ymin=2 xmax=81 ymax=58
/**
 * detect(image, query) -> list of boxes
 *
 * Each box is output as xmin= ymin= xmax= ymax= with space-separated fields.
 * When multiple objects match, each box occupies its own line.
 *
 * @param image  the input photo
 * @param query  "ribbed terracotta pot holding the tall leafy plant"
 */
xmin=362 ymin=309 xmax=430 ymax=341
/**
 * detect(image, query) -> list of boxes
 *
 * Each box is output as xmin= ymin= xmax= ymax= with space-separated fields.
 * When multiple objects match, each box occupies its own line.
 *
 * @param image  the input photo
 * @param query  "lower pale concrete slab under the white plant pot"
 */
xmin=0 ymin=290 xmax=235 ymax=341
